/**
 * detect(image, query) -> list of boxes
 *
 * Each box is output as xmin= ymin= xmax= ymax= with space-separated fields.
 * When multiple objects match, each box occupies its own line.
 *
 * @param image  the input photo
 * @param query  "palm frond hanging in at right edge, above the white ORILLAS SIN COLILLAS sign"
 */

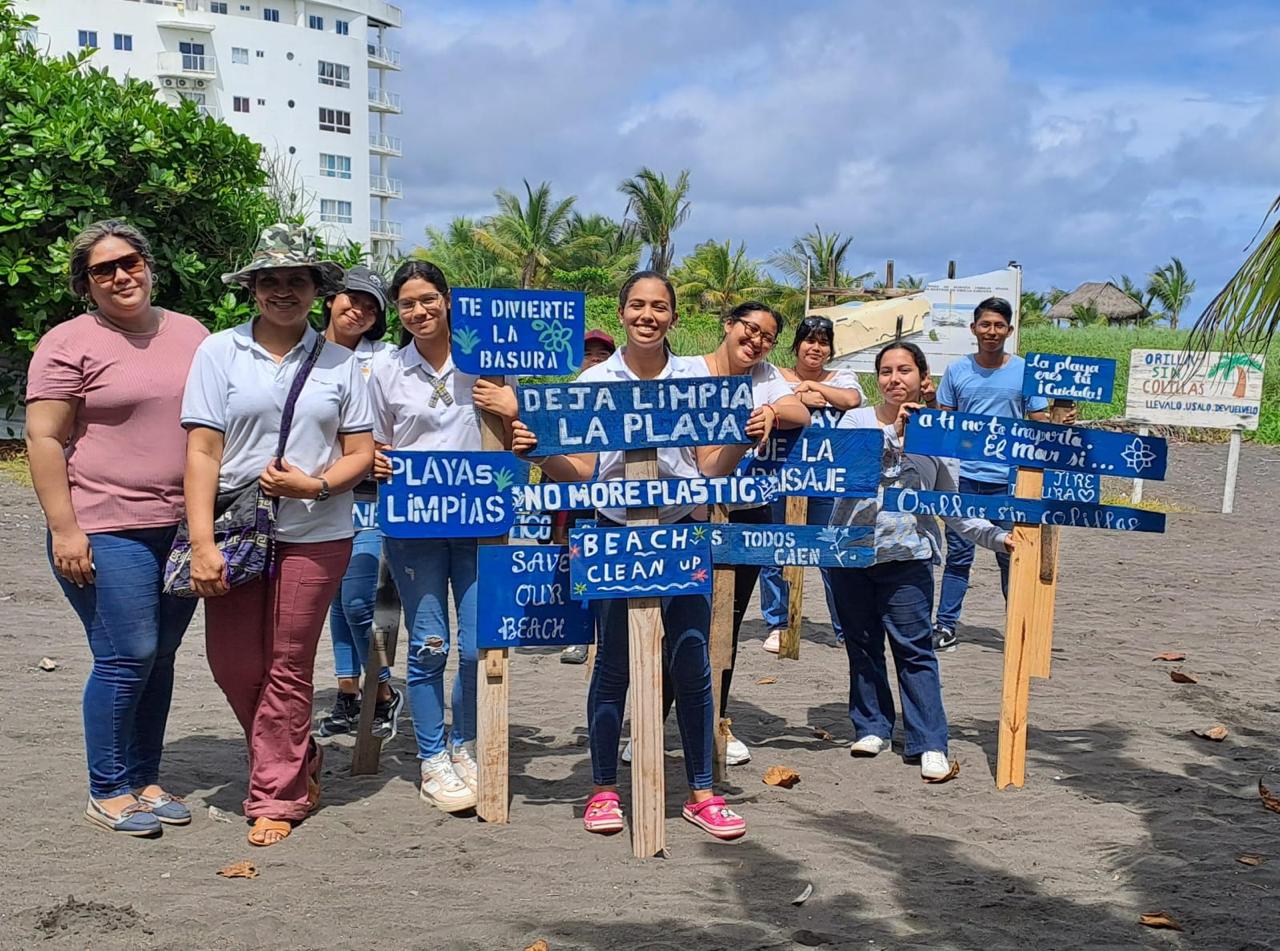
xmin=1188 ymin=197 xmax=1280 ymax=351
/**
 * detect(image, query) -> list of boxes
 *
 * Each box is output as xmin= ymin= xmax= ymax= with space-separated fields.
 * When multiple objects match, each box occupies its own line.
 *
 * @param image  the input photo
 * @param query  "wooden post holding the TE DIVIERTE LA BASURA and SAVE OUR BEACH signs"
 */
xmin=476 ymin=396 xmax=511 ymax=823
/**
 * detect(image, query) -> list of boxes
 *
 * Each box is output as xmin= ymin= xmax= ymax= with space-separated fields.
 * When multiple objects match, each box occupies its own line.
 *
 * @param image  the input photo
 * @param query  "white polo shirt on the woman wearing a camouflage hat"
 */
xmin=182 ymin=321 xmax=374 ymax=543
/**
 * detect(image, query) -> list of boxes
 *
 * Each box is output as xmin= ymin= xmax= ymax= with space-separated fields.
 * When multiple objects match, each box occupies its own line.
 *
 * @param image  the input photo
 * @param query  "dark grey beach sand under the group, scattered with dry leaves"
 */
xmin=0 ymin=445 xmax=1280 ymax=951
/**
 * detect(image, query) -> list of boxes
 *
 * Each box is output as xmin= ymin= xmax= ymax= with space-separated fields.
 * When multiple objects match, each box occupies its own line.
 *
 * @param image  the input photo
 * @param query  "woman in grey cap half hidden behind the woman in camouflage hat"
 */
xmin=317 ymin=266 xmax=404 ymax=740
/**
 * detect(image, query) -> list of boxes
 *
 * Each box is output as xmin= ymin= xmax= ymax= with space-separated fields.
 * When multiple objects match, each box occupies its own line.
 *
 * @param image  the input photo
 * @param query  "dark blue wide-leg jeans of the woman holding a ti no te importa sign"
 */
xmin=831 ymin=559 xmax=947 ymax=756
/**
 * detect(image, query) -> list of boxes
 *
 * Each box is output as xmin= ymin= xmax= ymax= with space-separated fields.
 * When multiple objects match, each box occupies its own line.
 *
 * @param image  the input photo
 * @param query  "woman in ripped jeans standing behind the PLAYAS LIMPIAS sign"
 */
xmin=370 ymin=260 xmax=515 ymax=813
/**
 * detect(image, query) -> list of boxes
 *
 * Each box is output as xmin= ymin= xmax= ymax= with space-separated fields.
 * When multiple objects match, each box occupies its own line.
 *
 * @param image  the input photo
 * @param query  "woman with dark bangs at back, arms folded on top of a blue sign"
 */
xmin=760 ymin=315 xmax=863 ymax=654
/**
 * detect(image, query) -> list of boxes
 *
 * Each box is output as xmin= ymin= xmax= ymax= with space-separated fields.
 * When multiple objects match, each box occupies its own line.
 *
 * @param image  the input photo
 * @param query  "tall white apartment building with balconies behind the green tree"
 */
xmin=17 ymin=0 xmax=403 ymax=259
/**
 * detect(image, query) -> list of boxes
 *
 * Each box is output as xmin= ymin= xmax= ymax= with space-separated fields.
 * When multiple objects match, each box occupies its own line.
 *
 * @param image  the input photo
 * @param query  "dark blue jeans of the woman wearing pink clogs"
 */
xmin=586 ymin=594 xmax=713 ymax=790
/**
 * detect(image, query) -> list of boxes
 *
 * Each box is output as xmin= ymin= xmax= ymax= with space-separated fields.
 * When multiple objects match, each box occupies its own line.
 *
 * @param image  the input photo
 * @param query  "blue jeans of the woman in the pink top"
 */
xmin=47 ymin=526 xmax=197 ymax=799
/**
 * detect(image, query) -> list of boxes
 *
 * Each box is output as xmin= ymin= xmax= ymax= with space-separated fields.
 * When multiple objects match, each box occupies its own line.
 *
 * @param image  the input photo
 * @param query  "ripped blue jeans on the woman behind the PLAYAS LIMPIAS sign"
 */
xmin=384 ymin=538 xmax=476 ymax=759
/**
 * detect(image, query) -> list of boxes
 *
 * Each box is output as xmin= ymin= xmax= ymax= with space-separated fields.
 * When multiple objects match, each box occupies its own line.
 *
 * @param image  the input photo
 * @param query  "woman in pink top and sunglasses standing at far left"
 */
xmin=27 ymin=220 xmax=209 ymax=836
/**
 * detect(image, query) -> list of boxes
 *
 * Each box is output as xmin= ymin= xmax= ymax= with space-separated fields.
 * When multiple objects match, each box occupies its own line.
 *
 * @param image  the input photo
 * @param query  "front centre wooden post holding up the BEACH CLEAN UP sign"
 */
xmin=626 ymin=449 xmax=665 ymax=859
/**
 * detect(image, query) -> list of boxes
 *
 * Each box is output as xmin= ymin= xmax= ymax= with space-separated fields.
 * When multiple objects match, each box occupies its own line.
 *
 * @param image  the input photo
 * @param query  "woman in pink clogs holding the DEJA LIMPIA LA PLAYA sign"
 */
xmin=512 ymin=271 xmax=752 ymax=838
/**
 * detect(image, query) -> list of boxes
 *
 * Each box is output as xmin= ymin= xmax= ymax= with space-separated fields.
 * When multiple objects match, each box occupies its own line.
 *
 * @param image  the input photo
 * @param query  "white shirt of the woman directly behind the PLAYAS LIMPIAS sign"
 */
xmin=369 ymin=340 xmax=516 ymax=452
